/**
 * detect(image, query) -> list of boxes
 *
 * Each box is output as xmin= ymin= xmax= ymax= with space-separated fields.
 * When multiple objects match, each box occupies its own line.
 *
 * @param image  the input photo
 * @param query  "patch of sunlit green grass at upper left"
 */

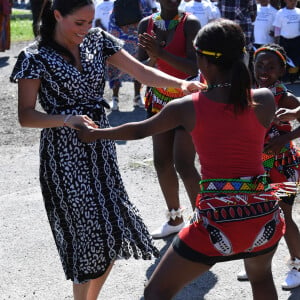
xmin=10 ymin=9 xmax=34 ymax=42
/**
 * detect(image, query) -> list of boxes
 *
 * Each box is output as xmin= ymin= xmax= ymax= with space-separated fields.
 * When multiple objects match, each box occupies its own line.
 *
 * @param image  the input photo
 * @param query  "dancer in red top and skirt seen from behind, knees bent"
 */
xmin=79 ymin=19 xmax=285 ymax=300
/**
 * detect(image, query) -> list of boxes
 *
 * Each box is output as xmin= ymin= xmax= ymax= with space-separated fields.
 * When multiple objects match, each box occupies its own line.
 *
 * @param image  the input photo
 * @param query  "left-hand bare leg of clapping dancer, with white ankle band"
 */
xmin=152 ymin=130 xmax=182 ymax=225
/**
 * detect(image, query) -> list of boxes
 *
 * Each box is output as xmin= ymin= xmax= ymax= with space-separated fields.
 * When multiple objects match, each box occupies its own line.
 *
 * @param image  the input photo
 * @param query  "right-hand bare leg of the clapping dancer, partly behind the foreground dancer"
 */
xmin=174 ymin=129 xmax=201 ymax=209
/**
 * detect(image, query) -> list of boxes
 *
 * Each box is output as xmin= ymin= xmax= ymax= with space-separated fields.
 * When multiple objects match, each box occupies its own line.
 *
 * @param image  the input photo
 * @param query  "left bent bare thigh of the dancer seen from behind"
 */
xmin=144 ymin=246 xmax=210 ymax=300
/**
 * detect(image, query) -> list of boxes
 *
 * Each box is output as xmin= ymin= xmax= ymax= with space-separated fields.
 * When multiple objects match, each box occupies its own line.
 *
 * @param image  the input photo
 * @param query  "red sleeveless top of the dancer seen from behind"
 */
xmin=191 ymin=93 xmax=267 ymax=179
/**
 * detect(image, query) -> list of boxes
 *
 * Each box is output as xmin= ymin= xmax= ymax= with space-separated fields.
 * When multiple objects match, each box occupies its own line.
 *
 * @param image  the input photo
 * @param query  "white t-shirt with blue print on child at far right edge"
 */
xmin=273 ymin=7 xmax=300 ymax=39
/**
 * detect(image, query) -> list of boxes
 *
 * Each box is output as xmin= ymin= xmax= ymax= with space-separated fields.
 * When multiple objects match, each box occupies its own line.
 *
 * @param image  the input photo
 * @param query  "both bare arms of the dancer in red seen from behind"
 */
xmin=78 ymin=89 xmax=275 ymax=143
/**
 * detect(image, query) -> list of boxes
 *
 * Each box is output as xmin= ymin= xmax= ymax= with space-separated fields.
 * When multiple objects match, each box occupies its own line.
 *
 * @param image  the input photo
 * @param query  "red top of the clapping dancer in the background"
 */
xmin=147 ymin=13 xmax=190 ymax=79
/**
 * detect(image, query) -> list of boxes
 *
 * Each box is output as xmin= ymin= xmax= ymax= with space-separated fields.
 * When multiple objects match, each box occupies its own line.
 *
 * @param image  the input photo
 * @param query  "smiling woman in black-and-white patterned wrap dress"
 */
xmin=11 ymin=0 xmax=200 ymax=300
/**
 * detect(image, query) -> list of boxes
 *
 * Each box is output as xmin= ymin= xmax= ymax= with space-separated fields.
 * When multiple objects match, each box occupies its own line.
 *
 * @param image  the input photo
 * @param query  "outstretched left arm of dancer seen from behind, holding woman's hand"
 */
xmin=78 ymin=96 xmax=195 ymax=142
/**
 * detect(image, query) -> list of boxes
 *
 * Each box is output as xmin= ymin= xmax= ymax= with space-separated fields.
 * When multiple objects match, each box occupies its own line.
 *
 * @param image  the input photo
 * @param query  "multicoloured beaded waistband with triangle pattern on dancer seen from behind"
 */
xmin=200 ymin=175 xmax=270 ymax=194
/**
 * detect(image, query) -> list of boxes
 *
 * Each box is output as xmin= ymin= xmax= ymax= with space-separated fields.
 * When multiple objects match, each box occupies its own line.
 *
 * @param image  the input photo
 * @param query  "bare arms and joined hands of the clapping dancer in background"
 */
xmin=138 ymin=15 xmax=200 ymax=75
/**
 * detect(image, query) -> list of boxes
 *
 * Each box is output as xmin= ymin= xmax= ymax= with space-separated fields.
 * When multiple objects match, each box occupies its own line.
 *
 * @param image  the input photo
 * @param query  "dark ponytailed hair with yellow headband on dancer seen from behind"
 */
xmin=194 ymin=19 xmax=253 ymax=113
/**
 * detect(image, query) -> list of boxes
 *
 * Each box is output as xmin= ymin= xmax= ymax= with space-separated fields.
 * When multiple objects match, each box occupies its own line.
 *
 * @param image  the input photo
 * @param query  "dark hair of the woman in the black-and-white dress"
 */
xmin=38 ymin=0 xmax=93 ymax=63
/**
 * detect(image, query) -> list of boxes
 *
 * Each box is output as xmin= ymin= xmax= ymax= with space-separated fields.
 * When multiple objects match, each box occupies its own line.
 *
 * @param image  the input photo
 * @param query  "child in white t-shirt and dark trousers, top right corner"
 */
xmin=273 ymin=0 xmax=300 ymax=83
